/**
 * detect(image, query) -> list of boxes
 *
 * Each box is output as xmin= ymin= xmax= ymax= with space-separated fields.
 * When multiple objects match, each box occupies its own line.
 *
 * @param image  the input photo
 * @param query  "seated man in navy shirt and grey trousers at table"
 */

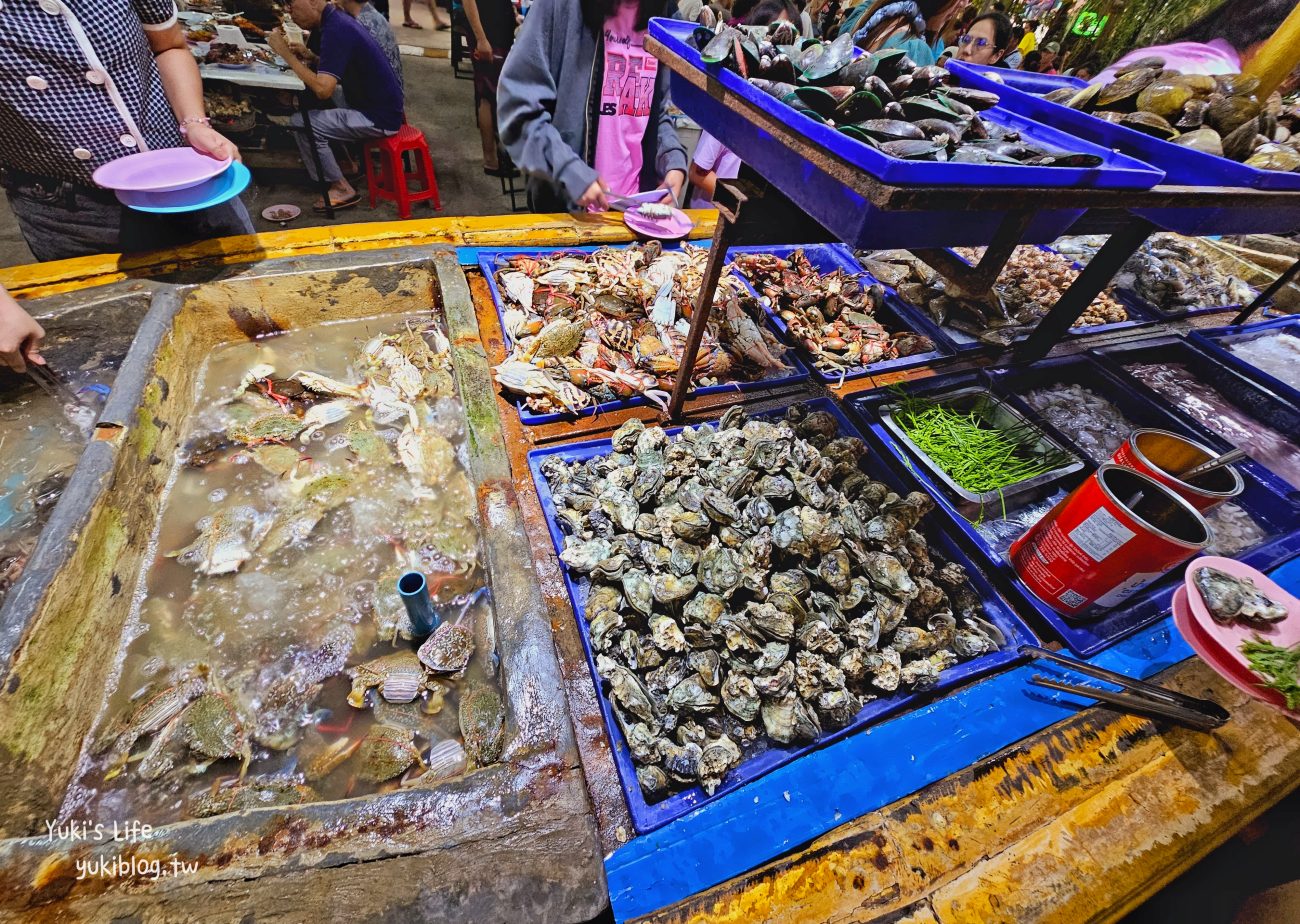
xmin=267 ymin=0 xmax=403 ymax=211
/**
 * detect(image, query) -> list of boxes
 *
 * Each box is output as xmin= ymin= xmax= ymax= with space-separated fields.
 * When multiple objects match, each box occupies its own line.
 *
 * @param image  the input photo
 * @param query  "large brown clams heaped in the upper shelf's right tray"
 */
xmin=1045 ymin=57 xmax=1300 ymax=172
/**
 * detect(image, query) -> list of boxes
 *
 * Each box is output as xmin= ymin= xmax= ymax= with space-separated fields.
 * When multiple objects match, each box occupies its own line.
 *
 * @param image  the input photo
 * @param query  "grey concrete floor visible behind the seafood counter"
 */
xmin=0 ymin=50 xmax=523 ymax=266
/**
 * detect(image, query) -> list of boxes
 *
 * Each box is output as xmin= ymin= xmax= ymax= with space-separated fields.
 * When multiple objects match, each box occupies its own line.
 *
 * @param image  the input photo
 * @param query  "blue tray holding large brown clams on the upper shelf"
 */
xmin=948 ymin=61 xmax=1300 ymax=235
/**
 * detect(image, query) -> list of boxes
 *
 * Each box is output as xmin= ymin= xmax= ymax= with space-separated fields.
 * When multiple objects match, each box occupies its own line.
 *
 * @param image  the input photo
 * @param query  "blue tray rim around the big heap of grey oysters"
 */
xmin=528 ymin=398 xmax=1035 ymax=834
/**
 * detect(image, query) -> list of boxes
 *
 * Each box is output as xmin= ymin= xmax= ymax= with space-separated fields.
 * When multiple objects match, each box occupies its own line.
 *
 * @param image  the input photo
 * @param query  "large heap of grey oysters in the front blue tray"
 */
xmin=541 ymin=405 xmax=1005 ymax=801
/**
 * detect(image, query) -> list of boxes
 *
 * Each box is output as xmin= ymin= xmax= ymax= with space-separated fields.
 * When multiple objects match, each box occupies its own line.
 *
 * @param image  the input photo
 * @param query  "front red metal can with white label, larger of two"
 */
xmin=1009 ymin=463 xmax=1210 ymax=616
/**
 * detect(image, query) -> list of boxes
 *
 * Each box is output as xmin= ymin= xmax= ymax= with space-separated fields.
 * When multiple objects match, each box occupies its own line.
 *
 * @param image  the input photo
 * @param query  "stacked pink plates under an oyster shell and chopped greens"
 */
xmin=1173 ymin=555 xmax=1300 ymax=719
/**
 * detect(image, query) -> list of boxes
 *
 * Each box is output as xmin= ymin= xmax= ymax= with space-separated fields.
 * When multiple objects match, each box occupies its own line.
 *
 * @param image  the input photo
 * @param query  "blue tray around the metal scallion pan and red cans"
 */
xmin=849 ymin=356 xmax=1300 ymax=656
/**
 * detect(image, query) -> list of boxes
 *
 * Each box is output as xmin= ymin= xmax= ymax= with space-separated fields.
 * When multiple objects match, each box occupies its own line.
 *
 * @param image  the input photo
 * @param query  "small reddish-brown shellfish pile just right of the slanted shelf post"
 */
xmin=735 ymin=248 xmax=935 ymax=376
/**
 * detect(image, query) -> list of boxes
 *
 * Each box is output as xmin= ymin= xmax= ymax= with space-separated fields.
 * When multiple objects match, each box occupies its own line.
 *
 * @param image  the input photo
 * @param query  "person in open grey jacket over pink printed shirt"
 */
xmin=497 ymin=0 xmax=686 ymax=212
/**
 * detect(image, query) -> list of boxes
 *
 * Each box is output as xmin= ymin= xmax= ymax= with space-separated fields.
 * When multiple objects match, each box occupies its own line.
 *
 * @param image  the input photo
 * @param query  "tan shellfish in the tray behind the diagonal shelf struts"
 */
xmin=859 ymin=247 xmax=1128 ymax=347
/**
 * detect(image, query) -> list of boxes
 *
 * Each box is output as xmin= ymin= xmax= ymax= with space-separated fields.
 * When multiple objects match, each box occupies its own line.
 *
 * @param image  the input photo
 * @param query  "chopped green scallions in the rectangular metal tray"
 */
xmin=894 ymin=395 xmax=1071 ymax=494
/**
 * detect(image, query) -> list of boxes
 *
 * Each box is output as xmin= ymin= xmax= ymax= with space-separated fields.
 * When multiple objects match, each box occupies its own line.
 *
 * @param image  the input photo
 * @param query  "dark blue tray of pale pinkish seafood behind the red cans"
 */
xmin=1091 ymin=330 xmax=1300 ymax=499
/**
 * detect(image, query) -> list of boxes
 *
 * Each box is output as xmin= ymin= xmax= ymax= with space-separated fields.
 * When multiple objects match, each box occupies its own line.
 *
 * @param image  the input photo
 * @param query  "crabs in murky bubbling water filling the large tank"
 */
xmin=66 ymin=317 xmax=504 ymax=823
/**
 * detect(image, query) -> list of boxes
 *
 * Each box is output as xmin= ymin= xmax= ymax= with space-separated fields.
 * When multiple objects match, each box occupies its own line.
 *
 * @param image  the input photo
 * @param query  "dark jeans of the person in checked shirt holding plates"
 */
xmin=4 ymin=177 xmax=254 ymax=261
